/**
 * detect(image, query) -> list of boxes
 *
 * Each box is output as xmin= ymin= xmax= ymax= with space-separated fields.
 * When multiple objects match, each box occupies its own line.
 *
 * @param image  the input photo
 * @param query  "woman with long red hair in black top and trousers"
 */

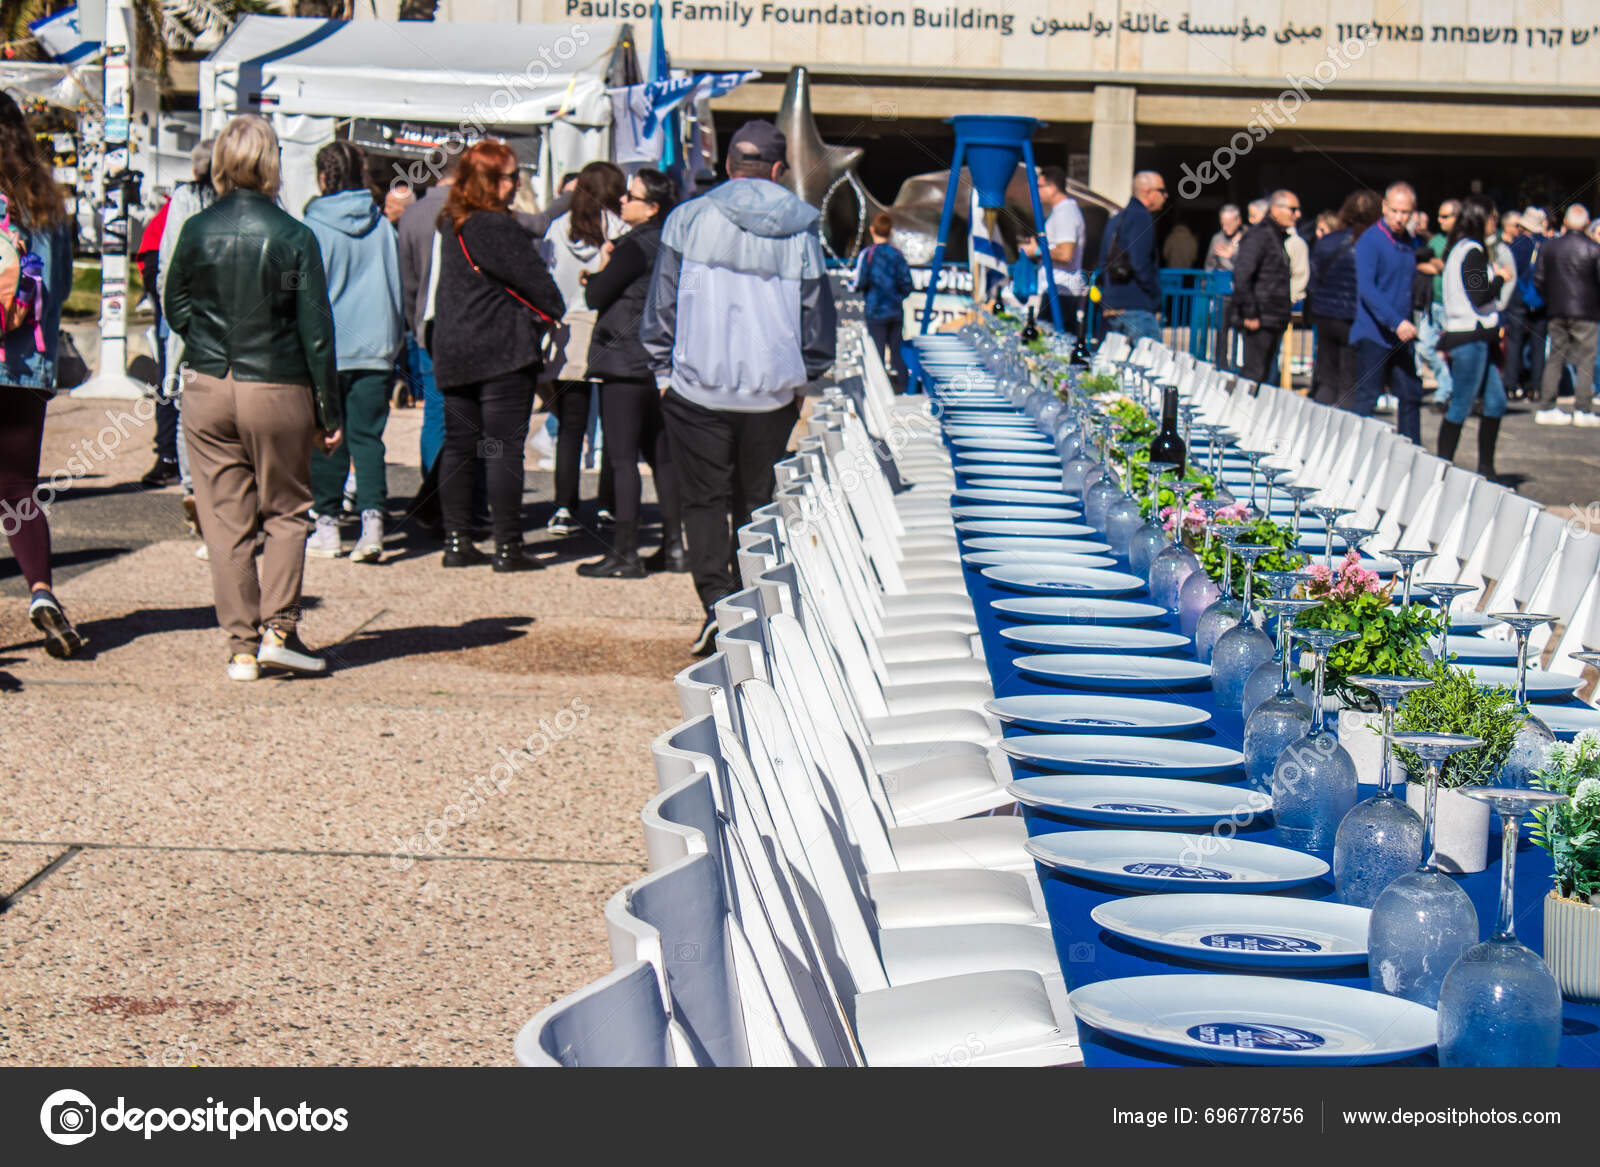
xmin=429 ymin=138 xmax=566 ymax=571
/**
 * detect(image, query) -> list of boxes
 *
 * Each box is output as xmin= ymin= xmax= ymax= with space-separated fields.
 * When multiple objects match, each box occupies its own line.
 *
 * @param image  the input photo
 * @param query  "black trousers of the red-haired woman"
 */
xmin=438 ymin=367 xmax=534 ymax=543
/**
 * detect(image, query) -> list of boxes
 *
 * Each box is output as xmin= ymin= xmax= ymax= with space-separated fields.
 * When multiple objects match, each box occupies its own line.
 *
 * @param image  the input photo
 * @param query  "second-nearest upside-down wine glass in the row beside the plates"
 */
xmin=1366 ymin=733 xmax=1483 ymax=1009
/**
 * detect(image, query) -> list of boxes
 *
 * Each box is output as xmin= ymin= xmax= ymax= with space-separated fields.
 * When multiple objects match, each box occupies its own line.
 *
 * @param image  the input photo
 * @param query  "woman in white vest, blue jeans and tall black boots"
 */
xmin=1438 ymin=195 xmax=1517 ymax=479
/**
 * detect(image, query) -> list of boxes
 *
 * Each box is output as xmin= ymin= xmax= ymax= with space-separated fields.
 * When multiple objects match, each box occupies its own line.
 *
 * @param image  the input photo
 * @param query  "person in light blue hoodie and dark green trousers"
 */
xmin=306 ymin=142 xmax=403 ymax=563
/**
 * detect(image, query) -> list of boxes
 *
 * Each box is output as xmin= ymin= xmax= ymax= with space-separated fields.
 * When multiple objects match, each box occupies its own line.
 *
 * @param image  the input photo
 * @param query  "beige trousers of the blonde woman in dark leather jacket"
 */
xmin=182 ymin=373 xmax=317 ymax=653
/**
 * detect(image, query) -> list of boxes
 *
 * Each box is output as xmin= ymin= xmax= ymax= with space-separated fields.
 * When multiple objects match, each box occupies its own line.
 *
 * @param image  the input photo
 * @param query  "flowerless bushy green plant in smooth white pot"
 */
xmin=1395 ymin=661 xmax=1528 ymax=872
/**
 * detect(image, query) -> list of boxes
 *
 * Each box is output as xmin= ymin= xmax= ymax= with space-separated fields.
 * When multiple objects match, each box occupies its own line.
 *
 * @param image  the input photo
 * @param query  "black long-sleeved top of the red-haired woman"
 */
xmin=429 ymin=211 xmax=566 ymax=389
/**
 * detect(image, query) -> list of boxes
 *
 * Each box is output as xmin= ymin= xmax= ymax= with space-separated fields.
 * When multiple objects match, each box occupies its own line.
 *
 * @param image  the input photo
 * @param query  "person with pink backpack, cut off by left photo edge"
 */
xmin=0 ymin=91 xmax=85 ymax=660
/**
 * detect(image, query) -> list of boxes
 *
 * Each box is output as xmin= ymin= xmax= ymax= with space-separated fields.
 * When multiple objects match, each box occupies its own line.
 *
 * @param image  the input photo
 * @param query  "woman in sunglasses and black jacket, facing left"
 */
xmin=578 ymin=170 xmax=686 ymax=579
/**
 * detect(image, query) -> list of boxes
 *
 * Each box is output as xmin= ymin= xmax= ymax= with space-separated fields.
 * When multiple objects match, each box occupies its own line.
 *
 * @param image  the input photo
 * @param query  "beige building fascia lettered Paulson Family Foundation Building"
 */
xmin=496 ymin=0 xmax=1600 ymax=93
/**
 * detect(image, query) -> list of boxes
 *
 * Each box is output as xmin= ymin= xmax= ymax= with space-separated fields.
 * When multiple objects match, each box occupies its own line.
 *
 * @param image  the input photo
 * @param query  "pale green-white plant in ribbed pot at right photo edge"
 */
xmin=1533 ymin=730 xmax=1600 ymax=1004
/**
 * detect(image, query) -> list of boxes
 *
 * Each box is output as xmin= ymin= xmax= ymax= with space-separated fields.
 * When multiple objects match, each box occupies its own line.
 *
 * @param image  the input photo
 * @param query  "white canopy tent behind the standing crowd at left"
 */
xmin=200 ymin=16 xmax=640 ymax=213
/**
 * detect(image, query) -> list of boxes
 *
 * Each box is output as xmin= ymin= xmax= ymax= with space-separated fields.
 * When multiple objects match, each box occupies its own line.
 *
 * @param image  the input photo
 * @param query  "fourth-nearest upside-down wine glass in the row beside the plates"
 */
xmin=1272 ymin=628 xmax=1360 ymax=852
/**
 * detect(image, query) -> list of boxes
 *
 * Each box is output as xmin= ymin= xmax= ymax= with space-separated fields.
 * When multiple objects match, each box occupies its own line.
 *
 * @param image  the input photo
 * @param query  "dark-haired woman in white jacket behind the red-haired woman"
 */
xmin=544 ymin=162 xmax=627 ymax=535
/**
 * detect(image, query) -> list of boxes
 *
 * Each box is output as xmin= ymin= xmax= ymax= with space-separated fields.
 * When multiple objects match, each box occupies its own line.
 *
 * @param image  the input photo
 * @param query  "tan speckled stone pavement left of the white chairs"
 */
xmin=0 ymin=397 xmax=699 ymax=1065
